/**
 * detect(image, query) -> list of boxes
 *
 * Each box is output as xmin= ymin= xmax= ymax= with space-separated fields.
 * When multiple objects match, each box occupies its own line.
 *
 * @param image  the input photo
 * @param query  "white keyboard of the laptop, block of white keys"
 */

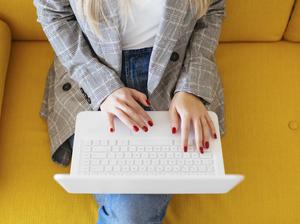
xmin=79 ymin=138 xmax=216 ymax=176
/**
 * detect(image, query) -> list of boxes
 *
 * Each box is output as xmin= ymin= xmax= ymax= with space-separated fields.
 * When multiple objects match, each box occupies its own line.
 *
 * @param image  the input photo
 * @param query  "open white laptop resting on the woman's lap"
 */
xmin=54 ymin=111 xmax=244 ymax=194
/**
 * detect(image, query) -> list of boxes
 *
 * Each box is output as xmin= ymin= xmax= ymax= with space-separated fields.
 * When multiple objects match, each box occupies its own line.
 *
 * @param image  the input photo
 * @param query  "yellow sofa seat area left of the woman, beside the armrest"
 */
xmin=0 ymin=41 xmax=97 ymax=224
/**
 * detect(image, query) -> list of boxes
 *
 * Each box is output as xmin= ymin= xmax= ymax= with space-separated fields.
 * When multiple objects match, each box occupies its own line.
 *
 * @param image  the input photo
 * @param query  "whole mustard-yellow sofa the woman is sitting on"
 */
xmin=0 ymin=0 xmax=300 ymax=224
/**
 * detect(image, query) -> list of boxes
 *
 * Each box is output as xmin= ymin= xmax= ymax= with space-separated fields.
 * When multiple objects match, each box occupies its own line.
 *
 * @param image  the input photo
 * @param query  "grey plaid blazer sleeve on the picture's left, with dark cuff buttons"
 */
xmin=33 ymin=0 xmax=124 ymax=110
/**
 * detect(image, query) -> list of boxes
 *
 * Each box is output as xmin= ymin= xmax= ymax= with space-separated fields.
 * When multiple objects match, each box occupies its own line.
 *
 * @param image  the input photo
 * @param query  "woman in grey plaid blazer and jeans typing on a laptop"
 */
xmin=34 ymin=0 xmax=224 ymax=224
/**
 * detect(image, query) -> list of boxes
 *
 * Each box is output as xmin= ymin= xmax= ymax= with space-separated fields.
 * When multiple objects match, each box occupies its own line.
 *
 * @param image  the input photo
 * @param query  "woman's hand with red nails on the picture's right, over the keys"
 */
xmin=169 ymin=92 xmax=217 ymax=153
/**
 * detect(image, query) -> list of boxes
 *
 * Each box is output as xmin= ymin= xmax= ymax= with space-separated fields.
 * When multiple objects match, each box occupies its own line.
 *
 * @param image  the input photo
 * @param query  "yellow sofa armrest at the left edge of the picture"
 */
xmin=0 ymin=20 xmax=11 ymax=117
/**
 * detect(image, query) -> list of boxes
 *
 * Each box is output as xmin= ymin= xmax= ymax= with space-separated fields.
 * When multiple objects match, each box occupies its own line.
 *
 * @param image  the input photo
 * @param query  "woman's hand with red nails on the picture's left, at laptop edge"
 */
xmin=100 ymin=87 xmax=153 ymax=132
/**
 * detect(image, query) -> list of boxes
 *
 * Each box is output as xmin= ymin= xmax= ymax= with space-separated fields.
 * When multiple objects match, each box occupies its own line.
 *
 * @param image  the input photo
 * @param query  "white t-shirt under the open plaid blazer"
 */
xmin=120 ymin=0 xmax=165 ymax=50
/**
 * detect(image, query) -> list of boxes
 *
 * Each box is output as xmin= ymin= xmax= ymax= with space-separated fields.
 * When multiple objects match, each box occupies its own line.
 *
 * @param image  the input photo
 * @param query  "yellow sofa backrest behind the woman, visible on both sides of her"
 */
xmin=0 ymin=0 xmax=299 ymax=41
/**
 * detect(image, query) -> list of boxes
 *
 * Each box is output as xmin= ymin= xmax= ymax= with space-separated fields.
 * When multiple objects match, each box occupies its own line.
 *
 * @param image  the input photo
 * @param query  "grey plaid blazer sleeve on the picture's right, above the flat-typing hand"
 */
xmin=174 ymin=0 xmax=225 ymax=104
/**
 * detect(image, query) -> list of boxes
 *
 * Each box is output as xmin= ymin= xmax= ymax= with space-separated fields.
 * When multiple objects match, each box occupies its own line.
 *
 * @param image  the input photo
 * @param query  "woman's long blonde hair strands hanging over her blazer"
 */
xmin=77 ymin=0 xmax=212 ymax=38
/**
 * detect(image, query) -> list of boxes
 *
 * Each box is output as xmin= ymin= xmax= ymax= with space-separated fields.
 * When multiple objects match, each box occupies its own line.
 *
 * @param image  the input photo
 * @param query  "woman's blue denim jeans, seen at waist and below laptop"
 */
xmin=69 ymin=47 xmax=172 ymax=224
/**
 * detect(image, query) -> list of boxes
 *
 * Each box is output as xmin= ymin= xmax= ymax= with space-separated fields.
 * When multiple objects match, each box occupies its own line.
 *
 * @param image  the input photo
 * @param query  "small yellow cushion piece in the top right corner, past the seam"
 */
xmin=284 ymin=0 xmax=300 ymax=42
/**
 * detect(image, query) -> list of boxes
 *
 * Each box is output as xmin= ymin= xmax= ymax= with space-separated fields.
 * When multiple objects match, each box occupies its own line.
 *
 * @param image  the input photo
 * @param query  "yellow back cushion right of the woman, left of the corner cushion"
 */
xmin=220 ymin=0 xmax=294 ymax=41
